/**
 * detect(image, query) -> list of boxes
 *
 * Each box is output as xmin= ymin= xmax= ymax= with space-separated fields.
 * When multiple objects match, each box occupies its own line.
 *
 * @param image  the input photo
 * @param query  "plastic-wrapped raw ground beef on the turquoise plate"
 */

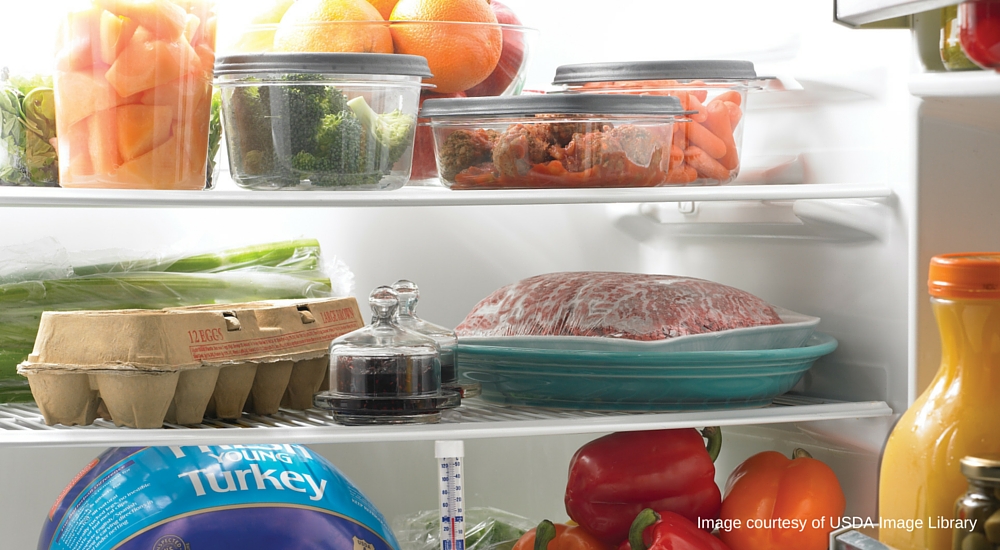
xmin=455 ymin=271 xmax=781 ymax=340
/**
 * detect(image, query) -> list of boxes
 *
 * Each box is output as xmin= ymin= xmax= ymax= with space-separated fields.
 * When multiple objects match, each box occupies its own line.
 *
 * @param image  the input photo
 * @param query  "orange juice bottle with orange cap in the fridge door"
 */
xmin=879 ymin=253 xmax=1000 ymax=550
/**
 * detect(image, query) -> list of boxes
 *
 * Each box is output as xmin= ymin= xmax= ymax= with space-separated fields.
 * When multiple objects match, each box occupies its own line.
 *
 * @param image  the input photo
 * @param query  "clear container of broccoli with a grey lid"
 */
xmin=215 ymin=53 xmax=430 ymax=190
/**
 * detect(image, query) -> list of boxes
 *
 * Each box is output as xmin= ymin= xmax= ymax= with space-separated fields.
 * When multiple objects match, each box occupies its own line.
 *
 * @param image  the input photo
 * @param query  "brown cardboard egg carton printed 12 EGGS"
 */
xmin=18 ymin=298 xmax=364 ymax=428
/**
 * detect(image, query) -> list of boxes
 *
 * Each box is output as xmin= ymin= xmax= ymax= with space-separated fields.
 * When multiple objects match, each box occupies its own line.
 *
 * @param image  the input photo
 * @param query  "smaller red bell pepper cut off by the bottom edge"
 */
xmin=618 ymin=508 xmax=729 ymax=550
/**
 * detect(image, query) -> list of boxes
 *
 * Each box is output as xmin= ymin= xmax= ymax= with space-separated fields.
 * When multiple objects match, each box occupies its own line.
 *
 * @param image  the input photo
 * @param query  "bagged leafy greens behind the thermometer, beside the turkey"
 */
xmin=393 ymin=507 xmax=537 ymax=550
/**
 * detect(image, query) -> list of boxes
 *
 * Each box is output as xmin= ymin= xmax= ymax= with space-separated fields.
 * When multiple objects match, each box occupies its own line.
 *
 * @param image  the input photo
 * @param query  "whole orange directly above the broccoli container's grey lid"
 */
xmin=274 ymin=0 xmax=393 ymax=53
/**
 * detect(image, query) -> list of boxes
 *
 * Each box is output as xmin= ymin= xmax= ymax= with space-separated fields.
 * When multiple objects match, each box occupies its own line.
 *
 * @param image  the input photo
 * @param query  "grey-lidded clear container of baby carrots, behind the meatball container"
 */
xmin=552 ymin=60 xmax=770 ymax=185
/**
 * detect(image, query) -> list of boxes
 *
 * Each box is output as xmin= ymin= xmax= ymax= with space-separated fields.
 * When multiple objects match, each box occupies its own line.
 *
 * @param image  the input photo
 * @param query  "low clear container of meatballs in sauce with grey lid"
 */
xmin=420 ymin=94 xmax=689 ymax=189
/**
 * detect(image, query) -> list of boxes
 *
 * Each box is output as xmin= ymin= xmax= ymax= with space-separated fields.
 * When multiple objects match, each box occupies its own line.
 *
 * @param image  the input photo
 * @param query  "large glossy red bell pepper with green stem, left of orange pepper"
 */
xmin=565 ymin=428 xmax=722 ymax=545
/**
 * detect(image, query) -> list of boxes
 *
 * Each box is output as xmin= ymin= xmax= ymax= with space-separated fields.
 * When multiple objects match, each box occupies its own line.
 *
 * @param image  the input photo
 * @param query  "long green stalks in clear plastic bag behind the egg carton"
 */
xmin=0 ymin=239 xmax=354 ymax=403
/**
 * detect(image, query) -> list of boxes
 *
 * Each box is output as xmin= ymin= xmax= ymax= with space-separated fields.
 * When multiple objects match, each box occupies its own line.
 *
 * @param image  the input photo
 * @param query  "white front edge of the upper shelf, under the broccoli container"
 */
xmin=0 ymin=187 xmax=892 ymax=208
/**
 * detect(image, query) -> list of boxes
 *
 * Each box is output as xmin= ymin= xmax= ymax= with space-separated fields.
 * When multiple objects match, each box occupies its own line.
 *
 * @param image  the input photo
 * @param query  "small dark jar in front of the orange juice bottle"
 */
xmin=952 ymin=456 xmax=1000 ymax=550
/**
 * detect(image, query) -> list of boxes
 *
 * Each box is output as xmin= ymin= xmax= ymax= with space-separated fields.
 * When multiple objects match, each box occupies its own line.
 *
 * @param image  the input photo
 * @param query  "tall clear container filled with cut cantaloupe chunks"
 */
xmin=53 ymin=0 xmax=216 ymax=189
